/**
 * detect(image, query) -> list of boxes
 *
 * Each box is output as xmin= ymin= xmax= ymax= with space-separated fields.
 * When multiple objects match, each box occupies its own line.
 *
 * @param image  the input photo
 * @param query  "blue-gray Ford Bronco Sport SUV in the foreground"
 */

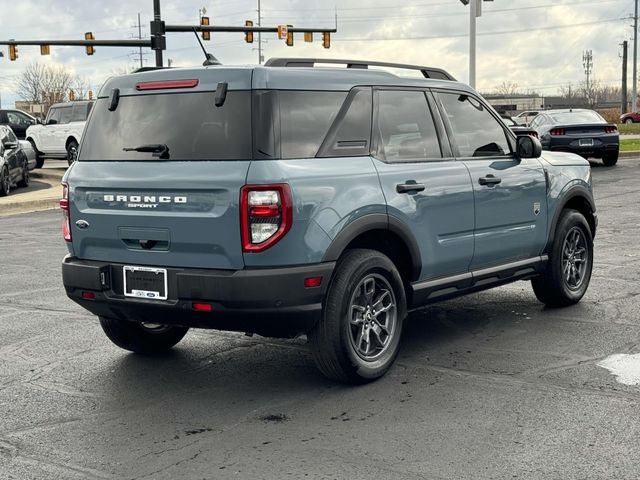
xmin=61 ymin=59 xmax=597 ymax=383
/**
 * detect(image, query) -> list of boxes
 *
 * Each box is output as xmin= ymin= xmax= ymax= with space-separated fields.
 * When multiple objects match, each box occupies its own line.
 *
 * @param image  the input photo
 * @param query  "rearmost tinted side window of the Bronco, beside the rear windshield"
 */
xmin=278 ymin=91 xmax=347 ymax=158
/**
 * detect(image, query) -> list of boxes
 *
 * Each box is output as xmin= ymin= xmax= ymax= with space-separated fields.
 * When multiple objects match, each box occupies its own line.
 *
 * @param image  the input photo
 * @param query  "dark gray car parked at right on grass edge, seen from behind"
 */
xmin=531 ymin=109 xmax=620 ymax=166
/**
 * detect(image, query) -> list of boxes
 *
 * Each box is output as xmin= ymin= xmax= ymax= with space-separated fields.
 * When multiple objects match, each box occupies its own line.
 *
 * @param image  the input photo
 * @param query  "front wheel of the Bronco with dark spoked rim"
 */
xmin=531 ymin=209 xmax=593 ymax=307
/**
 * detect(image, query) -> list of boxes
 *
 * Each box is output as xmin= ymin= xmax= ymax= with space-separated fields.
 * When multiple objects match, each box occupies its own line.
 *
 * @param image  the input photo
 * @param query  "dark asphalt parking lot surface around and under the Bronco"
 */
xmin=0 ymin=159 xmax=640 ymax=480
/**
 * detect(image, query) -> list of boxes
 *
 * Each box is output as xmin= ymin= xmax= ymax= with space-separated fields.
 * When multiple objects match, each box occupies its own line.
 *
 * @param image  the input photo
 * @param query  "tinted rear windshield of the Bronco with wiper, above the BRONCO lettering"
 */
xmin=78 ymin=91 xmax=251 ymax=161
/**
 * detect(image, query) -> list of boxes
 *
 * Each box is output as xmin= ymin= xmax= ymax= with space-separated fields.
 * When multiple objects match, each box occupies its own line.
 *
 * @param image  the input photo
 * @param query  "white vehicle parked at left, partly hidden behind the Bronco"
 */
xmin=26 ymin=101 xmax=93 ymax=168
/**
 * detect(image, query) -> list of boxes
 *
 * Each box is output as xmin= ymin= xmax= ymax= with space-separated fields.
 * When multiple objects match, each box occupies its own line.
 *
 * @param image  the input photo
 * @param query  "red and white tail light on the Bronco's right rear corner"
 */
xmin=240 ymin=183 xmax=293 ymax=252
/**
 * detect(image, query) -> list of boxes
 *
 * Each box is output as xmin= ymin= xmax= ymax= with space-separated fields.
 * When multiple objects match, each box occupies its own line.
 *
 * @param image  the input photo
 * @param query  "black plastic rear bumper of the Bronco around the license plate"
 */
xmin=62 ymin=256 xmax=335 ymax=337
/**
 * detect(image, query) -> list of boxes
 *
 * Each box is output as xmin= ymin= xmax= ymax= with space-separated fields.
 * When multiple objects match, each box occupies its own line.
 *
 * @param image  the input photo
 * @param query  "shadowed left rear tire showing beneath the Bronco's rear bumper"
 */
xmin=100 ymin=317 xmax=189 ymax=355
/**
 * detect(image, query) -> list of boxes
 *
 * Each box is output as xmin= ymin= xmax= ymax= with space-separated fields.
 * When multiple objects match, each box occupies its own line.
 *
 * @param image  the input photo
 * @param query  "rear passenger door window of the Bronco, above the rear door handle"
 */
xmin=377 ymin=90 xmax=442 ymax=161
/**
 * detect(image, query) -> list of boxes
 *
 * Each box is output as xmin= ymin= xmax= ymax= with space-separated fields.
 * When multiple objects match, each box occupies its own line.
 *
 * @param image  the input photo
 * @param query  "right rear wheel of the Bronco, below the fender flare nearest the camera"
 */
xmin=309 ymin=249 xmax=407 ymax=383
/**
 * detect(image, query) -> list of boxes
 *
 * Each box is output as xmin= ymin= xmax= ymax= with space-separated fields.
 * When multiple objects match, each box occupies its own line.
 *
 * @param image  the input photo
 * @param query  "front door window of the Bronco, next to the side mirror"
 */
xmin=439 ymin=93 xmax=511 ymax=157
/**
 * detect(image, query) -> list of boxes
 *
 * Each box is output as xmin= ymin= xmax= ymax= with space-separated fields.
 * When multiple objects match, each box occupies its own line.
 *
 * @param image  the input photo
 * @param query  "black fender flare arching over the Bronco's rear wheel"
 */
xmin=322 ymin=213 xmax=422 ymax=280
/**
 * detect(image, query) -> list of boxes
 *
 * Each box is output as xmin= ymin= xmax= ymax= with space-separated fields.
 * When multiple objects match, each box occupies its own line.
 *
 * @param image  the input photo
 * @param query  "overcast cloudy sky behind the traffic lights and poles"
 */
xmin=0 ymin=0 xmax=634 ymax=108
